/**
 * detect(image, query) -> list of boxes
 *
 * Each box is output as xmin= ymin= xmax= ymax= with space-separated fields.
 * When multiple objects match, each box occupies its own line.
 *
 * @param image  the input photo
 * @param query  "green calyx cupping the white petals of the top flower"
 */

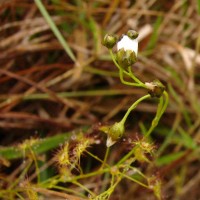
xmin=116 ymin=49 xmax=137 ymax=69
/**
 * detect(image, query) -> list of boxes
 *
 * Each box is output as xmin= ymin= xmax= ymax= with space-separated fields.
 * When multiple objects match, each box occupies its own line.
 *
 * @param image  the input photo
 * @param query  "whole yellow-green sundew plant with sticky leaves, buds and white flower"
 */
xmin=1 ymin=30 xmax=168 ymax=200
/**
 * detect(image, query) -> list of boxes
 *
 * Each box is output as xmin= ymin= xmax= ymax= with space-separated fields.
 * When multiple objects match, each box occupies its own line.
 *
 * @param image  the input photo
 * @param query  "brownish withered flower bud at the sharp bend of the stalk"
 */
xmin=145 ymin=80 xmax=165 ymax=98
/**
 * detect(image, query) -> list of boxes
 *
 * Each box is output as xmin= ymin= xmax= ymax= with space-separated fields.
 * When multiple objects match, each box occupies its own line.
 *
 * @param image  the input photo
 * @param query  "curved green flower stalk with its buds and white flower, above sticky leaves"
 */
xmin=100 ymin=30 xmax=169 ymax=147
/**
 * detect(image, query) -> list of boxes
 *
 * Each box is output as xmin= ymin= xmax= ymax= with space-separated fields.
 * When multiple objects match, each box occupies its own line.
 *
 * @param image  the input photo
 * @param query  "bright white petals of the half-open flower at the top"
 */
xmin=117 ymin=35 xmax=138 ymax=56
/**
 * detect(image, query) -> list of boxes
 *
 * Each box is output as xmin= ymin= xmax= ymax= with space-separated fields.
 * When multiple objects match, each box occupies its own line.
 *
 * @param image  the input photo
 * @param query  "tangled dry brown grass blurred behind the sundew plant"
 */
xmin=0 ymin=0 xmax=200 ymax=200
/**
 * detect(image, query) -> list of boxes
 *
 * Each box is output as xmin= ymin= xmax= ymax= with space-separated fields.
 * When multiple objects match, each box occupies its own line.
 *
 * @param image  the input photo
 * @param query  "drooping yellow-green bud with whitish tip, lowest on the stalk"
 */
xmin=100 ymin=122 xmax=125 ymax=147
